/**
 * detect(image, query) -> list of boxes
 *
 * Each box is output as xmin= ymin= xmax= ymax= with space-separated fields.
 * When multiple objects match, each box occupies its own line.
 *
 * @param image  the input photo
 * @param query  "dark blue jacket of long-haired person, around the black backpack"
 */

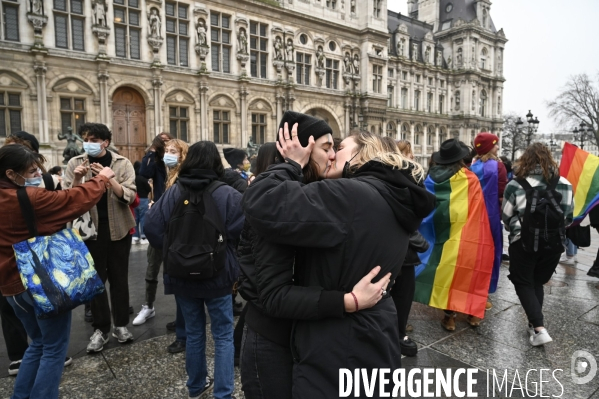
xmin=144 ymin=170 xmax=244 ymax=298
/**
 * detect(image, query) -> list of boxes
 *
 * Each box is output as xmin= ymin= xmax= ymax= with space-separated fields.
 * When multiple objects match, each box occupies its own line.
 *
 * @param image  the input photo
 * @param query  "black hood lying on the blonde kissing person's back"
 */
xmin=352 ymin=161 xmax=436 ymax=233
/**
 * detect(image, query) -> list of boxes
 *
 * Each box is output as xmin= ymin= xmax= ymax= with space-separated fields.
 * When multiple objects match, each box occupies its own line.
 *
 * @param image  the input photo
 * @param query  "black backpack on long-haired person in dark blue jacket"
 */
xmin=163 ymin=181 xmax=227 ymax=280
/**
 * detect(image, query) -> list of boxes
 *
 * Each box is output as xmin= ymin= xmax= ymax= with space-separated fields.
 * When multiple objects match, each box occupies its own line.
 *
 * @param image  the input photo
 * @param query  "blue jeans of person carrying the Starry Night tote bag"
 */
xmin=7 ymin=292 xmax=71 ymax=399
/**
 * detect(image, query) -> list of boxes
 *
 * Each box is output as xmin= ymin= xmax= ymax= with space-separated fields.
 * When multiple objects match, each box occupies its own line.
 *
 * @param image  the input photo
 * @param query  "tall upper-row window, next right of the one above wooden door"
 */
xmin=165 ymin=3 xmax=189 ymax=66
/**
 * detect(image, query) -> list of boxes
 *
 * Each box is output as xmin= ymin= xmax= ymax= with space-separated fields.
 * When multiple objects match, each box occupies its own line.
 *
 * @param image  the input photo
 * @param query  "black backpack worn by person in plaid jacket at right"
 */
xmin=516 ymin=175 xmax=566 ymax=252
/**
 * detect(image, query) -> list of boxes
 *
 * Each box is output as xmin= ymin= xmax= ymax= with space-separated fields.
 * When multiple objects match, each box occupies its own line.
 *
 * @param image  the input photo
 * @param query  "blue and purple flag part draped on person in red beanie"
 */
xmin=470 ymin=159 xmax=503 ymax=294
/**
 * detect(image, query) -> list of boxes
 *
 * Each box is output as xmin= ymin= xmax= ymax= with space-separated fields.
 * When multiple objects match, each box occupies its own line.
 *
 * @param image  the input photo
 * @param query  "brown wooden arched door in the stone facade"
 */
xmin=112 ymin=87 xmax=147 ymax=162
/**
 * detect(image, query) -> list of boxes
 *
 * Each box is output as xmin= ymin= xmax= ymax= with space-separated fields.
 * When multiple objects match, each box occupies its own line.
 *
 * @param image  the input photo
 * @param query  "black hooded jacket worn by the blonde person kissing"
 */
xmin=243 ymin=162 xmax=435 ymax=399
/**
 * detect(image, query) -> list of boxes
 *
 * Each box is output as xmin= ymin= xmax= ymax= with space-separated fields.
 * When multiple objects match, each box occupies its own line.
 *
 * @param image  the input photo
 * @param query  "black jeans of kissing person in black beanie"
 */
xmin=239 ymin=324 xmax=292 ymax=399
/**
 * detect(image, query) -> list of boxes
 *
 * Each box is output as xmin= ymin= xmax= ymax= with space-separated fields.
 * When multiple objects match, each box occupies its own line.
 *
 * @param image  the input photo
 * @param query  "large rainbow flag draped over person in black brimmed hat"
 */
xmin=414 ymin=168 xmax=495 ymax=318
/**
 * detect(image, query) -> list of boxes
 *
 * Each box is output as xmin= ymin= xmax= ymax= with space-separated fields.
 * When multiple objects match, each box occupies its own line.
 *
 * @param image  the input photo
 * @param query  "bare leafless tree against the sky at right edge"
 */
xmin=547 ymin=73 xmax=599 ymax=143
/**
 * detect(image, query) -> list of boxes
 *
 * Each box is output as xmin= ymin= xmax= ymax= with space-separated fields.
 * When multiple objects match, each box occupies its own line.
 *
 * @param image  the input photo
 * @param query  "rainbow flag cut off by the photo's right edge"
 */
xmin=559 ymin=143 xmax=599 ymax=225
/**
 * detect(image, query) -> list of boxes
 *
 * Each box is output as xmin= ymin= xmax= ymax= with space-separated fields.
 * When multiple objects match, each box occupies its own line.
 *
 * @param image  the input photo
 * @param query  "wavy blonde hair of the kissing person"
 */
xmin=349 ymin=131 xmax=424 ymax=183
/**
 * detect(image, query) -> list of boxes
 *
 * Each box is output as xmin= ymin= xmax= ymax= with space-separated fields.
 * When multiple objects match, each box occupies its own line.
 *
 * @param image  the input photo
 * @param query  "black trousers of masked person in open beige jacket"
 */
xmin=85 ymin=223 xmax=131 ymax=334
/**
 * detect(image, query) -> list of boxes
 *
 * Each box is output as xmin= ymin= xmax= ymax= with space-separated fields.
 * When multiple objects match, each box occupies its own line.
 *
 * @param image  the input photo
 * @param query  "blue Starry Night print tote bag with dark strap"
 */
xmin=13 ymin=187 xmax=104 ymax=319
